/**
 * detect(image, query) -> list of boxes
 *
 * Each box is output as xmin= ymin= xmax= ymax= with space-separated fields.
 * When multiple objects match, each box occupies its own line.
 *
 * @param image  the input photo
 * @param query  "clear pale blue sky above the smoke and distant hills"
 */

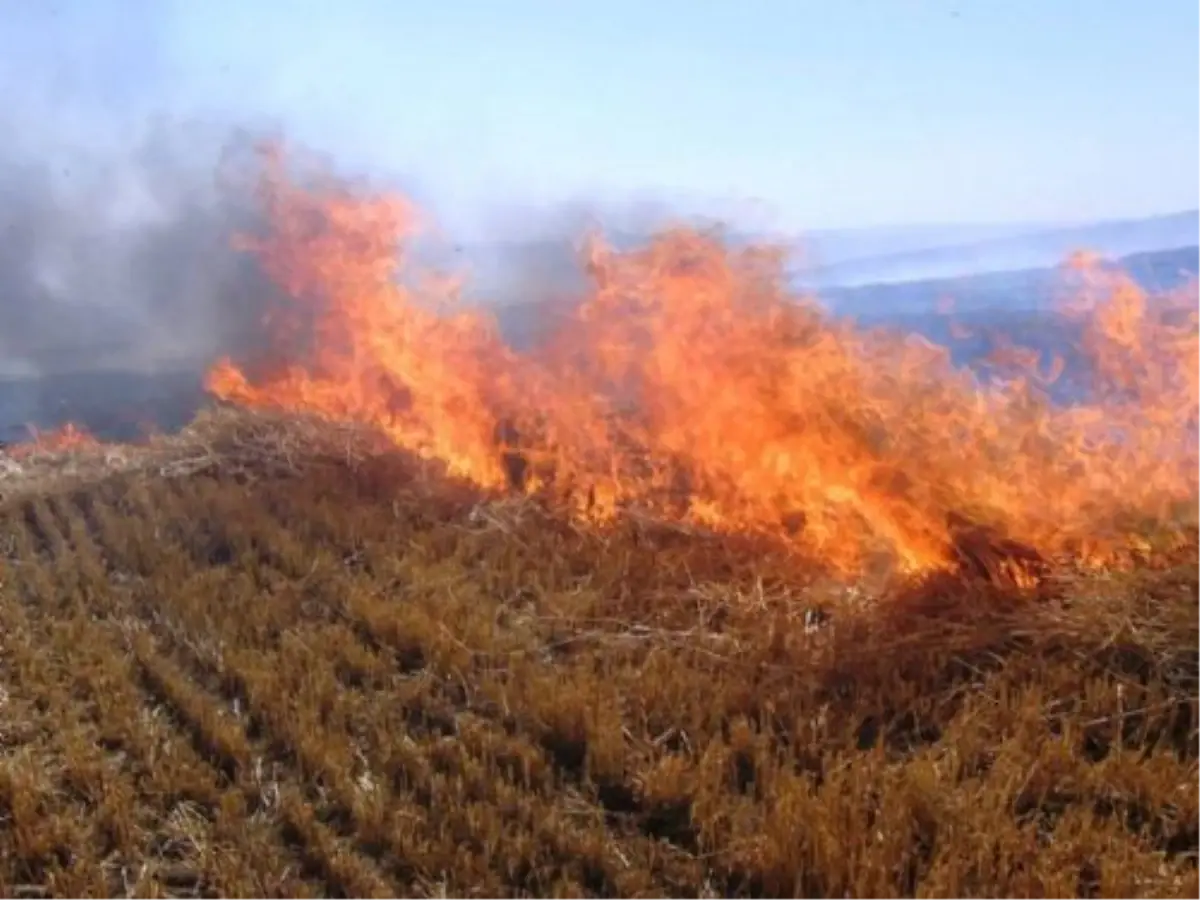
xmin=7 ymin=0 xmax=1200 ymax=229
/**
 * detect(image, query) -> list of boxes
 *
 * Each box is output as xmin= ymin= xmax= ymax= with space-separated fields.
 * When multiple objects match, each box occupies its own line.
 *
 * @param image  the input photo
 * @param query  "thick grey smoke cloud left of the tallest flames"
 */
xmin=0 ymin=122 xmax=300 ymax=374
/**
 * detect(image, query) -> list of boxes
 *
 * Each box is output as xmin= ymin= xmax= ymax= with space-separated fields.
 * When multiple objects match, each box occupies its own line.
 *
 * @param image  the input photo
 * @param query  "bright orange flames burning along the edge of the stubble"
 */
xmin=201 ymin=150 xmax=1200 ymax=572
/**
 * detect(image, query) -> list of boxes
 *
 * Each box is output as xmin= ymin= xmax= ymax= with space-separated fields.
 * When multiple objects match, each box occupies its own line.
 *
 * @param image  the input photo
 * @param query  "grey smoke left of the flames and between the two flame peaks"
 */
xmin=0 ymin=103 xmax=696 ymax=442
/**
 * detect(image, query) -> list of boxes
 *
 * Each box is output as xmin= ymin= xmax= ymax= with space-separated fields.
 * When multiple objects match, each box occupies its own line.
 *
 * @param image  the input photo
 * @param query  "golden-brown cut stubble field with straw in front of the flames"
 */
xmin=0 ymin=413 xmax=1200 ymax=898
